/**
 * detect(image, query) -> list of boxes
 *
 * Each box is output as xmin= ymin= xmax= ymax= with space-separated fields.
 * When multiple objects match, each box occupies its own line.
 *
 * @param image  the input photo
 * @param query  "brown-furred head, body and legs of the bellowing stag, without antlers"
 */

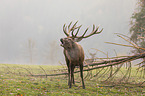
xmin=60 ymin=38 xmax=85 ymax=89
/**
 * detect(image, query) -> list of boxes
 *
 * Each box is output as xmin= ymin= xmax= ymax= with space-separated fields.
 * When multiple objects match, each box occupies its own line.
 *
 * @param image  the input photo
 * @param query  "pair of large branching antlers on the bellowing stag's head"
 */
xmin=63 ymin=21 xmax=103 ymax=42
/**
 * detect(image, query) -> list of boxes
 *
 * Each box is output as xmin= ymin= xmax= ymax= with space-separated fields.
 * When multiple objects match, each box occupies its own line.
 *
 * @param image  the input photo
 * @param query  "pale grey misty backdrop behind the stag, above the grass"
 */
xmin=0 ymin=0 xmax=137 ymax=65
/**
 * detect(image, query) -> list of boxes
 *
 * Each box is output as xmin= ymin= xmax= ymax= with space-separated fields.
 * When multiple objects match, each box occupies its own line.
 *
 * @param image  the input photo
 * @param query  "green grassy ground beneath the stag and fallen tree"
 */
xmin=0 ymin=64 xmax=145 ymax=96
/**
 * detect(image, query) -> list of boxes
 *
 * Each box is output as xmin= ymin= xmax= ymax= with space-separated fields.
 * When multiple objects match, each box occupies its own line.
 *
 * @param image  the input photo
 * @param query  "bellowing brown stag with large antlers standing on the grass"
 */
xmin=60 ymin=22 xmax=103 ymax=89
